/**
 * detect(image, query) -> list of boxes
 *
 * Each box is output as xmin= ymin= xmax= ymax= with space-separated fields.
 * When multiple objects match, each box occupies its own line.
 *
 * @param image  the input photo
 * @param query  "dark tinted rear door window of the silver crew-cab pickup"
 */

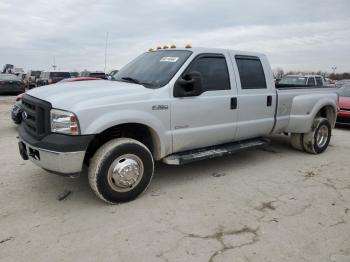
xmin=235 ymin=55 xmax=266 ymax=89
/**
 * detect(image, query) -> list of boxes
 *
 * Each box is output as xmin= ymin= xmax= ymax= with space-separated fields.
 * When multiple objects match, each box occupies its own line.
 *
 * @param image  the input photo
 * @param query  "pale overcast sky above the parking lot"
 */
xmin=0 ymin=0 xmax=350 ymax=72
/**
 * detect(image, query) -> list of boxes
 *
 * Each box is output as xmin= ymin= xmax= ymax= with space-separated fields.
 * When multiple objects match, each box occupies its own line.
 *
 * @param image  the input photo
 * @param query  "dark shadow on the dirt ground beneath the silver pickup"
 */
xmin=32 ymin=135 xmax=303 ymax=206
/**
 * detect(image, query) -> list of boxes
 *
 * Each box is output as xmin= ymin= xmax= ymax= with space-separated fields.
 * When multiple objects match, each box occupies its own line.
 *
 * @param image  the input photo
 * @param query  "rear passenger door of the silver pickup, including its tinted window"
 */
xmin=231 ymin=52 xmax=276 ymax=140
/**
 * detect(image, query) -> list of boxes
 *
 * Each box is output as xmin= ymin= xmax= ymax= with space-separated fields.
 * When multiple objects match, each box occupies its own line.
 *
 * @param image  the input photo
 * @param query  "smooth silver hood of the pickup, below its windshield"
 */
xmin=27 ymin=80 xmax=152 ymax=110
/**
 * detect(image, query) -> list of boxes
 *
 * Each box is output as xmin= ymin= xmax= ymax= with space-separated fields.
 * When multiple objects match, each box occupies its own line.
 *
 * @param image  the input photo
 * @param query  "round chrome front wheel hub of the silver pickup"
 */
xmin=108 ymin=154 xmax=144 ymax=192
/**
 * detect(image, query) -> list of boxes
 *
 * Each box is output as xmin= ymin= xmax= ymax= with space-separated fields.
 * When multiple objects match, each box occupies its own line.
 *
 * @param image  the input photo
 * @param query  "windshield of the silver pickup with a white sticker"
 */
xmin=114 ymin=50 xmax=192 ymax=88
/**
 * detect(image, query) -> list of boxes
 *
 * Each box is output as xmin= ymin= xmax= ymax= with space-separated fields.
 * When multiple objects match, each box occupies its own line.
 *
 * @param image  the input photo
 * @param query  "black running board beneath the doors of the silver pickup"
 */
xmin=163 ymin=138 xmax=270 ymax=165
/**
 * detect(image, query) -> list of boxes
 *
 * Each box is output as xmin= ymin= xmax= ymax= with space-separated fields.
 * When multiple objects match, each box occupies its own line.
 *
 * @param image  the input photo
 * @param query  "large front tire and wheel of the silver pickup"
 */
xmin=88 ymin=138 xmax=154 ymax=204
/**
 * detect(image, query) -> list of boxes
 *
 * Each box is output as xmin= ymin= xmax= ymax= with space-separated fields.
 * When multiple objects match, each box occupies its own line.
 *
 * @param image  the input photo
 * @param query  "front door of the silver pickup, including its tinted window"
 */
xmin=171 ymin=54 xmax=237 ymax=152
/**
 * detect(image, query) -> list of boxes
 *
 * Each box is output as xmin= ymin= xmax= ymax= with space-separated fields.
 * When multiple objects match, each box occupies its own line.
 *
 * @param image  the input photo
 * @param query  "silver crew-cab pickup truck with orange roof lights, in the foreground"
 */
xmin=19 ymin=48 xmax=338 ymax=203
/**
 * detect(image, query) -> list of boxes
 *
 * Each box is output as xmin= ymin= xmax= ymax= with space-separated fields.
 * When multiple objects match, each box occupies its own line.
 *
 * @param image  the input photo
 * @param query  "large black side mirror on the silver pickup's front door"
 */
xmin=174 ymin=71 xmax=202 ymax=97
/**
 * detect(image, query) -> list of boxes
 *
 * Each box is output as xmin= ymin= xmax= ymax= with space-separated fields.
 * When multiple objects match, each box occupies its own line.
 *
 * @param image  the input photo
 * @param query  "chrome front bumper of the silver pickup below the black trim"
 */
xmin=19 ymin=138 xmax=85 ymax=176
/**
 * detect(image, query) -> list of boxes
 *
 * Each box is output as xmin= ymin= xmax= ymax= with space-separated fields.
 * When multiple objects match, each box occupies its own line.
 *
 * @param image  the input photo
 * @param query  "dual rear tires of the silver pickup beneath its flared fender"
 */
xmin=303 ymin=118 xmax=332 ymax=154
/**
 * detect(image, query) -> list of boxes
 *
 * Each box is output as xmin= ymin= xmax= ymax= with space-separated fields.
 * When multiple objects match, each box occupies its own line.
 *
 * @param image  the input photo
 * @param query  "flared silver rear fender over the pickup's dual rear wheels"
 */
xmin=286 ymin=93 xmax=337 ymax=133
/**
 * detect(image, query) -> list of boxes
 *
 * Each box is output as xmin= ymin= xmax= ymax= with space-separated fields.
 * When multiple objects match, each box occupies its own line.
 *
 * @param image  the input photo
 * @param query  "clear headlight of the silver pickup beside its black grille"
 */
xmin=50 ymin=109 xmax=80 ymax=135
